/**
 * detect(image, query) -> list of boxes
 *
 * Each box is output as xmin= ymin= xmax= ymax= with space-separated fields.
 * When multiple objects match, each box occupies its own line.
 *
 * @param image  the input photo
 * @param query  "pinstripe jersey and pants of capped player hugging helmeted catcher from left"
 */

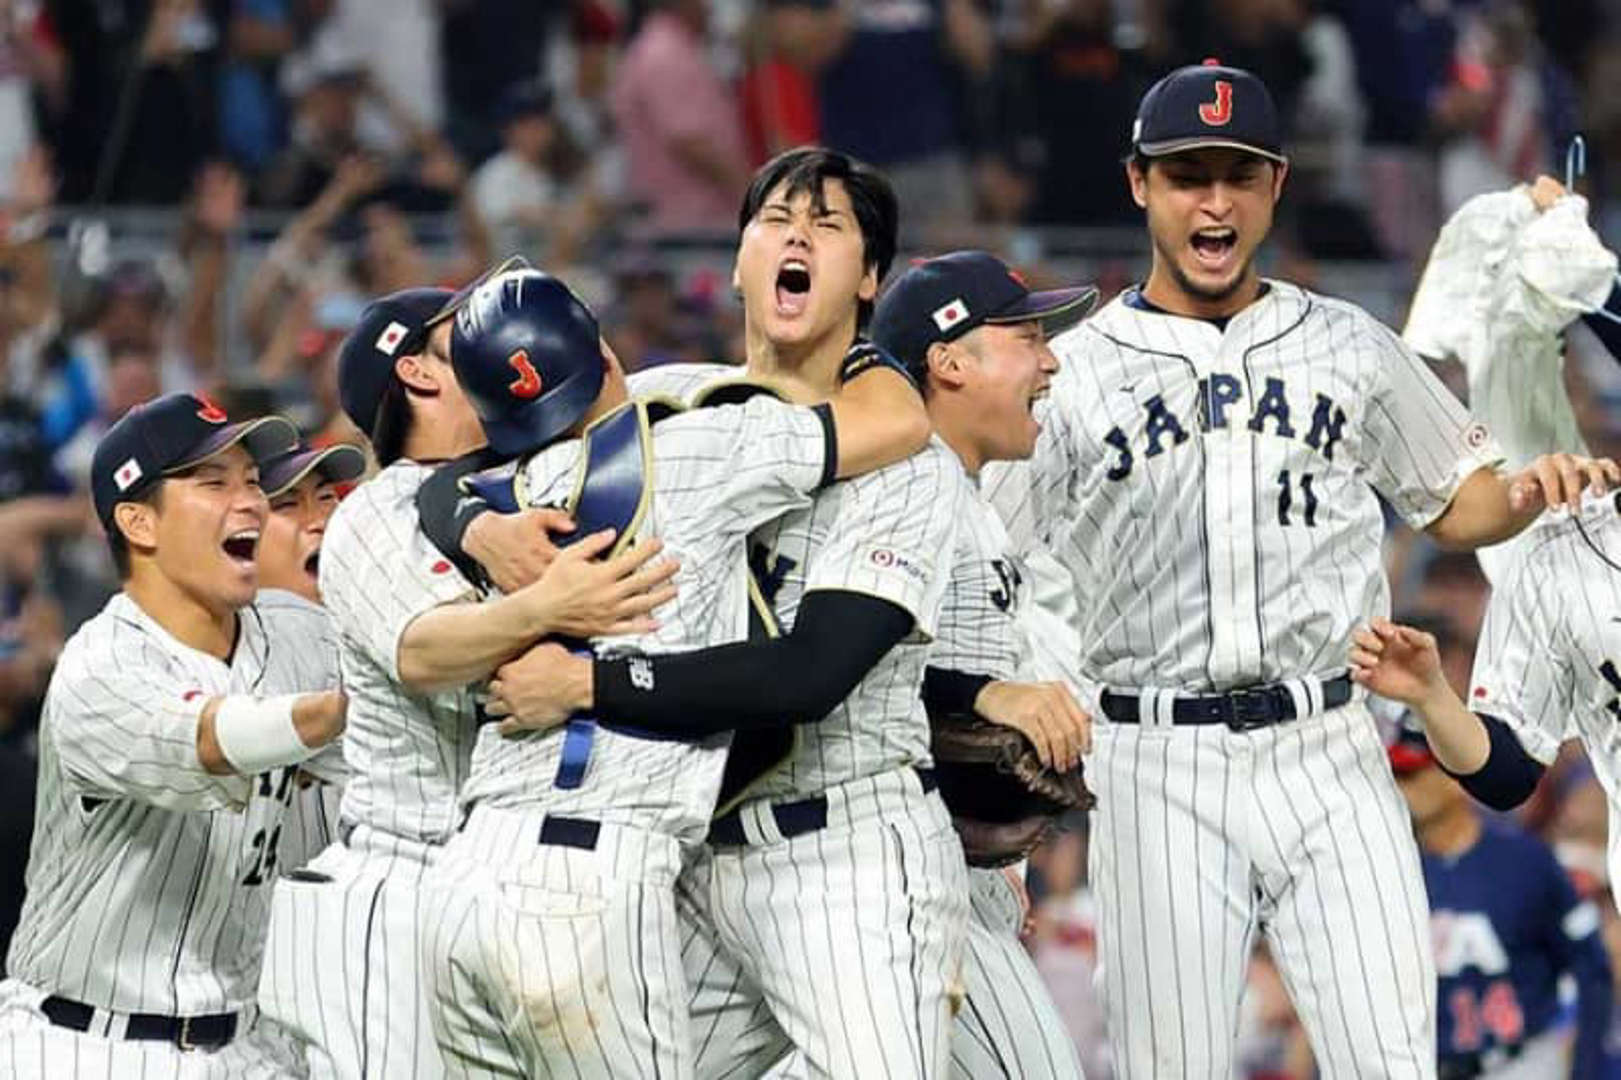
xmin=259 ymin=461 xmax=473 ymax=1080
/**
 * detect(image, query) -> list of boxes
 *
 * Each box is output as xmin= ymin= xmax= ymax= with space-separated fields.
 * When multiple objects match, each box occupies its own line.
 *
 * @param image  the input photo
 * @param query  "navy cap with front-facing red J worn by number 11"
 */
xmin=1131 ymin=60 xmax=1289 ymax=164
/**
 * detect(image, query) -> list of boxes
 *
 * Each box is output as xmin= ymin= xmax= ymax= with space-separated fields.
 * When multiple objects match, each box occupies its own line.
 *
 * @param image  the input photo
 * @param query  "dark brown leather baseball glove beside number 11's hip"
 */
xmin=930 ymin=714 xmax=1097 ymax=866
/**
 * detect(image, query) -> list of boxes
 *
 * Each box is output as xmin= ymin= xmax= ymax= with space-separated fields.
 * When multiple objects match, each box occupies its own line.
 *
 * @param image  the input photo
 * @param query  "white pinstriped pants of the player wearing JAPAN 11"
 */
xmin=1086 ymin=702 xmax=1436 ymax=1080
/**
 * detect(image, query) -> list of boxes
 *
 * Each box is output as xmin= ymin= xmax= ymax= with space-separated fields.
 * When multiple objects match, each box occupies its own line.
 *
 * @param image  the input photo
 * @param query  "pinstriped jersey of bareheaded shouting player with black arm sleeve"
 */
xmin=634 ymin=355 xmax=966 ymax=798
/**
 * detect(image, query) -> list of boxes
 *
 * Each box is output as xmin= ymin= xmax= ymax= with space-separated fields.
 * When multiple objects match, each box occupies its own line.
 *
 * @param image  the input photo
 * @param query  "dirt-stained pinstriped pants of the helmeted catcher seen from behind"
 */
xmin=423 ymin=808 xmax=692 ymax=1080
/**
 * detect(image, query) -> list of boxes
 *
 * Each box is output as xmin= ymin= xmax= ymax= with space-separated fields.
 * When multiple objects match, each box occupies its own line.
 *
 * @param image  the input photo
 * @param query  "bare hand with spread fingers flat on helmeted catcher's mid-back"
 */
xmin=522 ymin=529 xmax=679 ymax=637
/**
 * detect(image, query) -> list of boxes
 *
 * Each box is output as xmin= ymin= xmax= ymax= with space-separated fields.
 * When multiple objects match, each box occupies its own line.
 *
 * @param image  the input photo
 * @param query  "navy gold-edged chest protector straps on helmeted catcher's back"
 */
xmin=547 ymin=390 xmax=681 ymax=788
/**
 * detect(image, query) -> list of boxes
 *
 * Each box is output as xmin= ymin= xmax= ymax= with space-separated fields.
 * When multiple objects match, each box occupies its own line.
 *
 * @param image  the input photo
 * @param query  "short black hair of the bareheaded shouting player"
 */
xmin=738 ymin=146 xmax=901 ymax=326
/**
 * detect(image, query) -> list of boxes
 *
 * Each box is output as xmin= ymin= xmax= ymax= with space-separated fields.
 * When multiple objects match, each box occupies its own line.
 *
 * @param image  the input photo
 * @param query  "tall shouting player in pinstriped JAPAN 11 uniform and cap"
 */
xmin=987 ymin=63 xmax=1602 ymax=1077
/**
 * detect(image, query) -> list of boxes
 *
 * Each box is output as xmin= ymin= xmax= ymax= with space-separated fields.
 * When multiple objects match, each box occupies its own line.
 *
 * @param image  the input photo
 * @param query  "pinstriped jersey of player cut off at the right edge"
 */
xmin=1469 ymin=496 xmax=1621 ymax=882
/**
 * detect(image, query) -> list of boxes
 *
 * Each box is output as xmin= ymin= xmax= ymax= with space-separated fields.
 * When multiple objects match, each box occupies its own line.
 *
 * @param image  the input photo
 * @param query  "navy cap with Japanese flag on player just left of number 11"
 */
xmin=867 ymin=251 xmax=1097 ymax=376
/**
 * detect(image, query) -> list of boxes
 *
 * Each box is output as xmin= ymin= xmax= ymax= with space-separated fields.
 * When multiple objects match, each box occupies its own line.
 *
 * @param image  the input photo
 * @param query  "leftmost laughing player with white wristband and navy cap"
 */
xmin=0 ymin=394 xmax=344 ymax=1080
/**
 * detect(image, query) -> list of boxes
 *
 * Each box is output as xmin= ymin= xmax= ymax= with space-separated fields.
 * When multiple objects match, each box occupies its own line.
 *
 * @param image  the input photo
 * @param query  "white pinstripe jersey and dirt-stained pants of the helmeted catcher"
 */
xmin=425 ymin=397 xmax=827 ymax=1077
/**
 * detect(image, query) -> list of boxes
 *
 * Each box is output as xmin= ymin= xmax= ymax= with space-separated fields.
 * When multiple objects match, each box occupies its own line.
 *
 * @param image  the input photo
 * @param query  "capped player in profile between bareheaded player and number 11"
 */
xmin=872 ymin=251 xmax=1097 ymax=1078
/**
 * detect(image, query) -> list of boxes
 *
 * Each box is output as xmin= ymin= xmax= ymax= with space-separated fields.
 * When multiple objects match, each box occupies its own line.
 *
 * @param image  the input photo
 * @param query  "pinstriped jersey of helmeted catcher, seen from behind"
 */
xmin=464 ymin=397 xmax=828 ymax=837
